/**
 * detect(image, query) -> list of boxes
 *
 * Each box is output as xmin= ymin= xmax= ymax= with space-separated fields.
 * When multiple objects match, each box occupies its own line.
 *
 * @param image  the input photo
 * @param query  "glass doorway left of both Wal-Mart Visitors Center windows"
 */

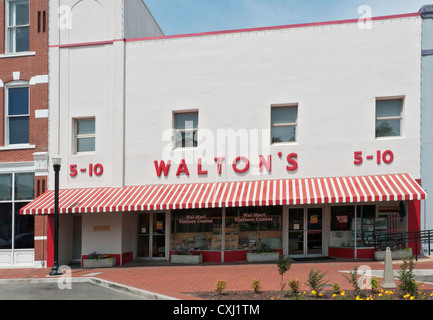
xmin=137 ymin=212 xmax=165 ymax=259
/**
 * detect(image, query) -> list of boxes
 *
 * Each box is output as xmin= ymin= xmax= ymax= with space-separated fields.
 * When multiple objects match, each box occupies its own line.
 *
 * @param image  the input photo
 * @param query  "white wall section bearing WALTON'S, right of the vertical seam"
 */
xmin=125 ymin=17 xmax=421 ymax=185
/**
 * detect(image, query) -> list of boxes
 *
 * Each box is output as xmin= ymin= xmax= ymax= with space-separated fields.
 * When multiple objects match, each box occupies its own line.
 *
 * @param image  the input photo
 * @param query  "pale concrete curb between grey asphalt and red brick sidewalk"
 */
xmin=0 ymin=277 xmax=179 ymax=300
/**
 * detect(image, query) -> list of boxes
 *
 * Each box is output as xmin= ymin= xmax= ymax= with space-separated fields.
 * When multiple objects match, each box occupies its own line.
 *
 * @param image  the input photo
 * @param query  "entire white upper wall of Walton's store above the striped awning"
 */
xmin=50 ymin=0 xmax=421 ymax=188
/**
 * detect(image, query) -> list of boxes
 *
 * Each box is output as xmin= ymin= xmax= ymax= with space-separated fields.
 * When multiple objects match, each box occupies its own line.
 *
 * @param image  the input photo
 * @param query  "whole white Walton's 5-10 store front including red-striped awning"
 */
xmin=22 ymin=0 xmax=426 ymax=264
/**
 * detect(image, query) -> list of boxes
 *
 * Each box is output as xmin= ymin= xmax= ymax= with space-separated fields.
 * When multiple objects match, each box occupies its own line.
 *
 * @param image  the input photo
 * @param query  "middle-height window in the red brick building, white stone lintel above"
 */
xmin=5 ymin=86 xmax=29 ymax=145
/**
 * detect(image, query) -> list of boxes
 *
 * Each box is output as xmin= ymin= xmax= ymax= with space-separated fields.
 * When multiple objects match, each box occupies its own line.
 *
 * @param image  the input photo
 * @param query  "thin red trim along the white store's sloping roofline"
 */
xmin=48 ymin=12 xmax=420 ymax=48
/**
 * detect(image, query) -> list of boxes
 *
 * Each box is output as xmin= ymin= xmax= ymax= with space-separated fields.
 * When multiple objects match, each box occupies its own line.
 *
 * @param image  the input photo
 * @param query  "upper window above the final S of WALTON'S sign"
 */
xmin=271 ymin=106 xmax=298 ymax=143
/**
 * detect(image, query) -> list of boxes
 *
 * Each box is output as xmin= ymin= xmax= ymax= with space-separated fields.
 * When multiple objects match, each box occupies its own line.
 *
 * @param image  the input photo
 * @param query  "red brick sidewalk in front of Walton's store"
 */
xmin=0 ymin=257 xmax=433 ymax=300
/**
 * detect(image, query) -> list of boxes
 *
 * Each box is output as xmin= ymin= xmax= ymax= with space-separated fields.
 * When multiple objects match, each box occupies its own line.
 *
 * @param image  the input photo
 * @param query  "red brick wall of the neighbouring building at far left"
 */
xmin=0 ymin=0 xmax=48 ymax=261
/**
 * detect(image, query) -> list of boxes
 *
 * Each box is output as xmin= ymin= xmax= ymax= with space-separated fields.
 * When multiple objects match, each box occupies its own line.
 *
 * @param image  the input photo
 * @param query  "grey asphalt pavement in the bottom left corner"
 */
xmin=0 ymin=282 xmax=147 ymax=300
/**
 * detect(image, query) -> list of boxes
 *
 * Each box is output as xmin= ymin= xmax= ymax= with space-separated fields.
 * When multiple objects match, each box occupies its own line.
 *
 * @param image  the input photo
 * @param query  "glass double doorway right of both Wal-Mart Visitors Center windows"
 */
xmin=289 ymin=208 xmax=323 ymax=257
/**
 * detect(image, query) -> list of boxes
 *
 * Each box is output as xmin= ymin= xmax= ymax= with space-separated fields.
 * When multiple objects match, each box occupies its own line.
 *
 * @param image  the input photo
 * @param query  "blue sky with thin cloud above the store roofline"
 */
xmin=144 ymin=0 xmax=433 ymax=35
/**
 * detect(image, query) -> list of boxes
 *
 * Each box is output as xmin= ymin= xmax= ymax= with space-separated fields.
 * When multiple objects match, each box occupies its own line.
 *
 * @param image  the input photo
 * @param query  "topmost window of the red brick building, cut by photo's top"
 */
xmin=5 ymin=0 xmax=30 ymax=53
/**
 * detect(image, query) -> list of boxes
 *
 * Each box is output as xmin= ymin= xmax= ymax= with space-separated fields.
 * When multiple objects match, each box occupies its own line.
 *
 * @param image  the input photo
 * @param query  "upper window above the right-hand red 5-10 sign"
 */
xmin=376 ymin=99 xmax=403 ymax=138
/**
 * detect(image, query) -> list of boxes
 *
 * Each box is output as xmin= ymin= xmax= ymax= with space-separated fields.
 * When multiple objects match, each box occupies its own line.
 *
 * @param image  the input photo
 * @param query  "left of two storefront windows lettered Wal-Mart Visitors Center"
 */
xmin=171 ymin=209 xmax=222 ymax=250
